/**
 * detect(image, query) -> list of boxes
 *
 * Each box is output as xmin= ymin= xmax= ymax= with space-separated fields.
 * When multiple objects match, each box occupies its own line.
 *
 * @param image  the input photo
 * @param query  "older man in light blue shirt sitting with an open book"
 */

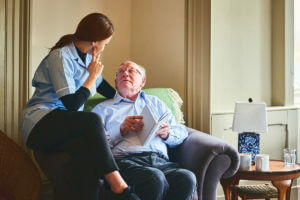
xmin=93 ymin=61 xmax=196 ymax=200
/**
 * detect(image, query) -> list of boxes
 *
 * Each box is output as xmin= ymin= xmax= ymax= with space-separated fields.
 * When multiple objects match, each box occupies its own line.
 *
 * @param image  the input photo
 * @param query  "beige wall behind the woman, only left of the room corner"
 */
xmin=31 ymin=0 xmax=131 ymax=92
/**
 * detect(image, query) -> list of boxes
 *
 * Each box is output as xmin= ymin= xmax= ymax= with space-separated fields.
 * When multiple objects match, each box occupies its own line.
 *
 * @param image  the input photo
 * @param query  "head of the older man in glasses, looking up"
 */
xmin=116 ymin=61 xmax=146 ymax=97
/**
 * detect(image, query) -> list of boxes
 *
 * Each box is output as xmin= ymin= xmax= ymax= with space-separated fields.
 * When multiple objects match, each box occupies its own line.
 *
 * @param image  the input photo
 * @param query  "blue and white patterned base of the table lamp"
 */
xmin=238 ymin=132 xmax=259 ymax=162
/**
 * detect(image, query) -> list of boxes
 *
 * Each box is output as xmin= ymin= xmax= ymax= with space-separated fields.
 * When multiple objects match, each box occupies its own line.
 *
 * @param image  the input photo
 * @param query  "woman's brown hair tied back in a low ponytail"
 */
xmin=50 ymin=13 xmax=114 ymax=52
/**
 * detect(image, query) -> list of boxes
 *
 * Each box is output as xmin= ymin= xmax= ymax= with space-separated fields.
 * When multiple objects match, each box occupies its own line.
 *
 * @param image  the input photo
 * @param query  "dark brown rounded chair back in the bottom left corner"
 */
xmin=0 ymin=131 xmax=41 ymax=200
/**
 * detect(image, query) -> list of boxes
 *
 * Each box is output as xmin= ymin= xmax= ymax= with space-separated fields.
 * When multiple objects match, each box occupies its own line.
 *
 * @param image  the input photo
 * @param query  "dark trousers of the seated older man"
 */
xmin=115 ymin=152 xmax=197 ymax=200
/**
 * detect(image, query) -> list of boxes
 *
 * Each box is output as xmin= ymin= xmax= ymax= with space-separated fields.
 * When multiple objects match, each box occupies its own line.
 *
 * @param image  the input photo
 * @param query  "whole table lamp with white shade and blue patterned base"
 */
xmin=232 ymin=98 xmax=268 ymax=161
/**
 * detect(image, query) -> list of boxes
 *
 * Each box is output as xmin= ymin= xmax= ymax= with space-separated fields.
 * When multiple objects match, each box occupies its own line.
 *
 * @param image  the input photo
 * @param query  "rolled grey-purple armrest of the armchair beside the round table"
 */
xmin=177 ymin=128 xmax=239 ymax=200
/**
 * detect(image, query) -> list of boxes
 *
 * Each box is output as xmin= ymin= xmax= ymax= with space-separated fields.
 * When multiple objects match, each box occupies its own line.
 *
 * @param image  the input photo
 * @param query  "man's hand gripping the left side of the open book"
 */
xmin=120 ymin=116 xmax=144 ymax=136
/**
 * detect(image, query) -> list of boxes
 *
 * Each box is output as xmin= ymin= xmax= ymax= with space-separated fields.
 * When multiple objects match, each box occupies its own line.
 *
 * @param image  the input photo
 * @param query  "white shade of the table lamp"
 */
xmin=232 ymin=102 xmax=268 ymax=133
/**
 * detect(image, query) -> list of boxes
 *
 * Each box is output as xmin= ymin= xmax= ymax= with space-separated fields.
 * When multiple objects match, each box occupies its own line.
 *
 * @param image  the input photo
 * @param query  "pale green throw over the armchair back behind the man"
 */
xmin=84 ymin=88 xmax=184 ymax=124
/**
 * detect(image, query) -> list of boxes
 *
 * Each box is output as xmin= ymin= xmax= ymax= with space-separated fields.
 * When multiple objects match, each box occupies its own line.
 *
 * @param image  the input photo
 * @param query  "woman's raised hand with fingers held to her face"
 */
xmin=82 ymin=48 xmax=104 ymax=93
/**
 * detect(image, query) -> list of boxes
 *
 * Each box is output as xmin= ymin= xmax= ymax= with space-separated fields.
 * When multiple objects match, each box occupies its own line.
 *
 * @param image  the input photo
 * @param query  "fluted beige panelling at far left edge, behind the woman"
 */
xmin=0 ymin=0 xmax=30 ymax=145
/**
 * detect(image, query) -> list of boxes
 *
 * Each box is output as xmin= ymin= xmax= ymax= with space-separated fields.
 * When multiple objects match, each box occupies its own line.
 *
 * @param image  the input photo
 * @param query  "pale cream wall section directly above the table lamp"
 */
xmin=211 ymin=0 xmax=272 ymax=113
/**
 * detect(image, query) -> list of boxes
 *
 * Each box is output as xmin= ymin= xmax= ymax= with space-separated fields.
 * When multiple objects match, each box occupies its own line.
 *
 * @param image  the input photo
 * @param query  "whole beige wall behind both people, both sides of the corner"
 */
xmin=31 ymin=0 xmax=185 ymax=101
